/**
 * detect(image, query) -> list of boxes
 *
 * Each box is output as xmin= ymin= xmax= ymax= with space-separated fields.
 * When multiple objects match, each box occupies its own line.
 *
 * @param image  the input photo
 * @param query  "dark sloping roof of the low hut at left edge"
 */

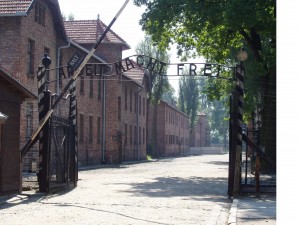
xmin=0 ymin=68 xmax=37 ymax=98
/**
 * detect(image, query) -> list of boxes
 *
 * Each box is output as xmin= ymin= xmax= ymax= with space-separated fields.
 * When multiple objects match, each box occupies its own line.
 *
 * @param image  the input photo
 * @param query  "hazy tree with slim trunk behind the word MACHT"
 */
xmin=135 ymin=37 xmax=170 ymax=157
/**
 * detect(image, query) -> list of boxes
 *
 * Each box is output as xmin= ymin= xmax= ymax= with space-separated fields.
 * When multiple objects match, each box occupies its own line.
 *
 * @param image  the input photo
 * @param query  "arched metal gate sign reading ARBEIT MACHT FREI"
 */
xmin=59 ymin=54 xmax=234 ymax=78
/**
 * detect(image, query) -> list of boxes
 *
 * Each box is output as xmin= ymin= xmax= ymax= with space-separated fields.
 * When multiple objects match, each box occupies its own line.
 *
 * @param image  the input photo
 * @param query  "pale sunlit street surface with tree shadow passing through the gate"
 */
xmin=0 ymin=154 xmax=231 ymax=225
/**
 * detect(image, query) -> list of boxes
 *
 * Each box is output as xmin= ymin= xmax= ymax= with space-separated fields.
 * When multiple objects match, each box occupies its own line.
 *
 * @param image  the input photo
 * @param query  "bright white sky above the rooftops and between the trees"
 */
xmin=59 ymin=0 xmax=203 ymax=95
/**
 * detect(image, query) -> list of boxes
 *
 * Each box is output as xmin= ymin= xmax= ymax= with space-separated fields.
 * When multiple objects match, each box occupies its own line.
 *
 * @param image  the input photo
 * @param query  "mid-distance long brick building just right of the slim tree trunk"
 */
xmin=149 ymin=100 xmax=190 ymax=156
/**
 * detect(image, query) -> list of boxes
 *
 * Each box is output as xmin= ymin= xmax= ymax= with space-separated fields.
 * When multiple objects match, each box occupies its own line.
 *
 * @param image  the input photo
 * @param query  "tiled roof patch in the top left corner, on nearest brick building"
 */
xmin=0 ymin=0 xmax=34 ymax=16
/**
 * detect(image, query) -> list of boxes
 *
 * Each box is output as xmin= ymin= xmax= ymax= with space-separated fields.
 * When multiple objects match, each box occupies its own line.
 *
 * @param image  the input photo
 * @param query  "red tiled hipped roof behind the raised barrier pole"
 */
xmin=64 ymin=16 xmax=130 ymax=50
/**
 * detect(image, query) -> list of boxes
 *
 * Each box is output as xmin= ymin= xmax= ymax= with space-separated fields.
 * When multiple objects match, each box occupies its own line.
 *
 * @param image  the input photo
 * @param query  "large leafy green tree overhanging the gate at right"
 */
xmin=134 ymin=0 xmax=276 ymax=169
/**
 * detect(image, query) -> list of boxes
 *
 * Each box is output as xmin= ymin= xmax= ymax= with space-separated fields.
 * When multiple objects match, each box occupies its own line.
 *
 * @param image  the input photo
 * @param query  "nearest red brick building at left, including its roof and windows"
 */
xmin=0 ymin=0 xmax=66 ymax=170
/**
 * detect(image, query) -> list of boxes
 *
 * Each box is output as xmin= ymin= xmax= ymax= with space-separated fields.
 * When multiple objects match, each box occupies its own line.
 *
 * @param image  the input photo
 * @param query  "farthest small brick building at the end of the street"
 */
xmin=191 ymin=113 xmax=210 ymax=147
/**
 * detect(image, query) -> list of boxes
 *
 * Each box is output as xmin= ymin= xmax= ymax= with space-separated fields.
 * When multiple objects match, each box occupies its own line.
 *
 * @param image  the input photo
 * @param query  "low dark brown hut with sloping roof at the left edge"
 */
xmin=0 ymin=69 xmax=37 ymax=195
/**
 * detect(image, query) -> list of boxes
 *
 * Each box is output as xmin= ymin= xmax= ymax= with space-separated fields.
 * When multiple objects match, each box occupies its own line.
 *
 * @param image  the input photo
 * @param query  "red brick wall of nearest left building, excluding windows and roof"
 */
xmin=0 ymin=1 xmax=66 ymax=170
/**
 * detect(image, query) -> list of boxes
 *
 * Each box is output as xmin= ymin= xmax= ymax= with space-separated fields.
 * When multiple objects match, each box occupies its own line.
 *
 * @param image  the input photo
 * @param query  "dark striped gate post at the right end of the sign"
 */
xmin=233 ymin=61 xmax=245 ymax=197
